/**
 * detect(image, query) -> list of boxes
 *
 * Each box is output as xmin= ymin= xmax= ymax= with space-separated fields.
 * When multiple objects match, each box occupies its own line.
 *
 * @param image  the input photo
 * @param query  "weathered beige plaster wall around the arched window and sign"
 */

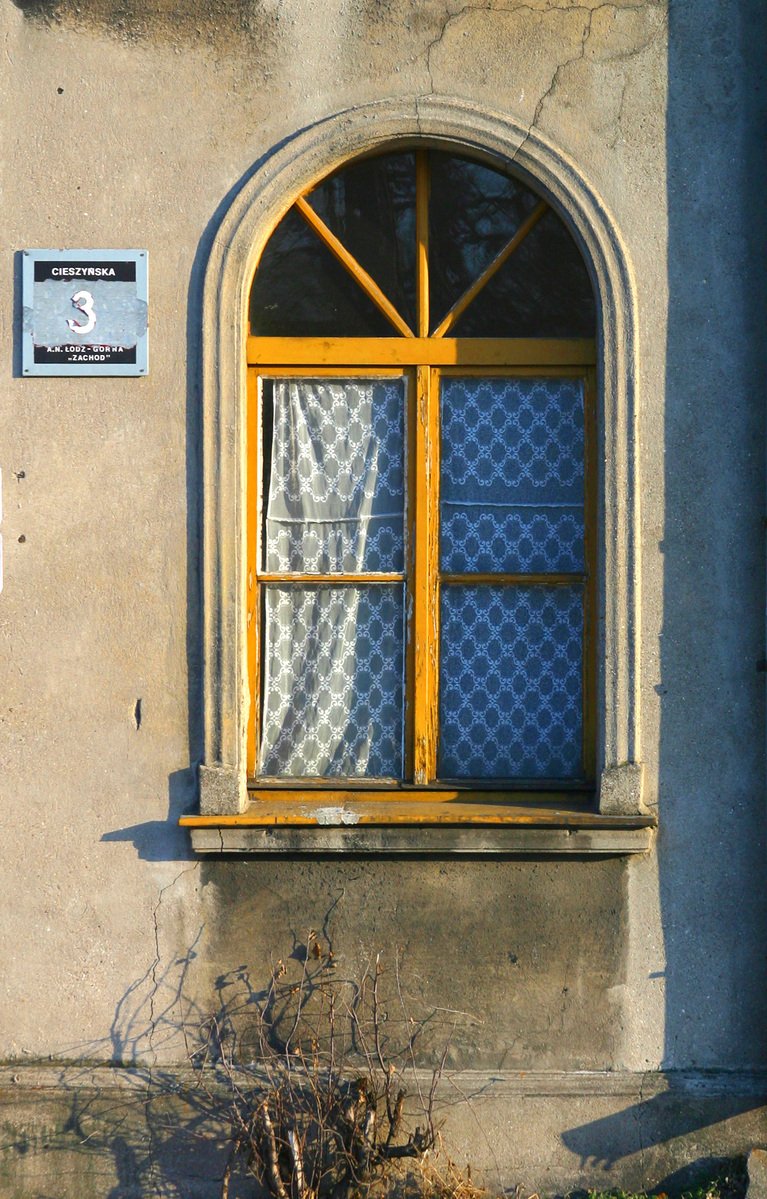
xmin=0 ymin=0 xmax=767 ymax=1194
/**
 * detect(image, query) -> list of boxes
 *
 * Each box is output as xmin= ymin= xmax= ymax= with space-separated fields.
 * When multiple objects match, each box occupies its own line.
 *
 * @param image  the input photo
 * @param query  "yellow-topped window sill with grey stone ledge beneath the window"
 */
xmin=179 ymin=791 xmax=656 ymax=856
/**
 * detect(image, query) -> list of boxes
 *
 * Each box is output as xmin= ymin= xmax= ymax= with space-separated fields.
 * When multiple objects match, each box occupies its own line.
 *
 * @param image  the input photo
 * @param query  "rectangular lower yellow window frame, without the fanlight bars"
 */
xmin=247 ymin=337 xmax=597 ymax=805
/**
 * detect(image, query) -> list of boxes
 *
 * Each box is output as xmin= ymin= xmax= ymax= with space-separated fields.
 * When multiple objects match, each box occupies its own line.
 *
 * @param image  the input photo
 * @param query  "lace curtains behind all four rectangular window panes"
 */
xmin=259 ymin=376 xmax=584 ymax=778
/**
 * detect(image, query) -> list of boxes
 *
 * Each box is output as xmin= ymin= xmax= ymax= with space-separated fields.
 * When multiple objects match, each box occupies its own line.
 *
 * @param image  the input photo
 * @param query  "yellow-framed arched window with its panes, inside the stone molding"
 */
xmin=247 ymin=149 xmax=598 ymax=803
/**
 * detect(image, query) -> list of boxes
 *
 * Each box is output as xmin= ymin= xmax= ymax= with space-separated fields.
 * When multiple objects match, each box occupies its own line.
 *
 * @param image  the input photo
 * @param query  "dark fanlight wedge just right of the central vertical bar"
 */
xmin=429 ymin=151 xmax=539 ymax=336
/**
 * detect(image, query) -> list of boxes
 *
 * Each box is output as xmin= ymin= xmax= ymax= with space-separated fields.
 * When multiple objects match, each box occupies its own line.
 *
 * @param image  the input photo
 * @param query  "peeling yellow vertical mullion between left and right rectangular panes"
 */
xmin=412 ymin=367 xmax=439 ymax=785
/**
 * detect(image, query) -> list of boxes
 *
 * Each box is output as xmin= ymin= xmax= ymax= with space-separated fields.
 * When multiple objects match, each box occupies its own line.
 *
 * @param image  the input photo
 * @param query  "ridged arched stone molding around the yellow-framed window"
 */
xmin=200 ymin=97 xmax=641 ymax=815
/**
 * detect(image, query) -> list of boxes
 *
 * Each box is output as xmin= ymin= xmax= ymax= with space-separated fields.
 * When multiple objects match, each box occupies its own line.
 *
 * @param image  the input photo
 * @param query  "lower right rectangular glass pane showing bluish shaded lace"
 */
xmin=437 ymin=586 xmax=584 ymax=779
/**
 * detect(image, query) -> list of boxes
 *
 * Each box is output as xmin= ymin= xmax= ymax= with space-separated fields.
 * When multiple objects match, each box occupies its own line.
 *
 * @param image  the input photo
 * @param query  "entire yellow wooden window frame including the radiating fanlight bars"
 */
xmin=240 ymin=150 xmax=597 ymax=803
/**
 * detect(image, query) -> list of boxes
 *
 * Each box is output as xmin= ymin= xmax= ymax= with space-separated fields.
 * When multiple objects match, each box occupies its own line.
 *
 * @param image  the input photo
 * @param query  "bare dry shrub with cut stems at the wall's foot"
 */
xmin=191 ymin=932 xmax=453 ymax=1199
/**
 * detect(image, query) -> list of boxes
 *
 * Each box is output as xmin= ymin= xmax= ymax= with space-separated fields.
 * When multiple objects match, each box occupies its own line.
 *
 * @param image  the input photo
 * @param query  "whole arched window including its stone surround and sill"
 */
xmin=181 ymin=105 xmax=654 ymax=854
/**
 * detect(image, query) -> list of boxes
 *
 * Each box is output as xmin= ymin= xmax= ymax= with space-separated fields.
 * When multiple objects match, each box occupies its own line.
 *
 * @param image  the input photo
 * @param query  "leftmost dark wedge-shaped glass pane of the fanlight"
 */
xmin=250 ymin=209 xmax=397 ymax=337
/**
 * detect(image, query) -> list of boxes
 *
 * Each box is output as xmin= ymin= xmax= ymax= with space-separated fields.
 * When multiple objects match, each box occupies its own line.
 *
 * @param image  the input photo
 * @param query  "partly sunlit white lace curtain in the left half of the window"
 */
xmin=259 ymin=378 xmax=405 ymax=778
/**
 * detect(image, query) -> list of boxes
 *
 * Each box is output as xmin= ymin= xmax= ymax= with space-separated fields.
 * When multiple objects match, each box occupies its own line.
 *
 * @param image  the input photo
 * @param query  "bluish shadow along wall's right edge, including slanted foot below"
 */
xmin=563 ymin=0 xmax=767 ymax=1183
